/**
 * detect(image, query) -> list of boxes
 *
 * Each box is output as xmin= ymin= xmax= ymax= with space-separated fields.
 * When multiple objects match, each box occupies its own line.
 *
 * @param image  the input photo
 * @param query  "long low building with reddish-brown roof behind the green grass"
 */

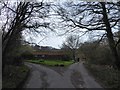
xmin=33 ymin=51 xmax=69 ymax=60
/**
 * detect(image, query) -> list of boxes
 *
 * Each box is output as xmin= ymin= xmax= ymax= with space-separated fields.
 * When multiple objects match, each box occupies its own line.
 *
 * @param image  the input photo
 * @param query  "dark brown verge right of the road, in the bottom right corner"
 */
xmin=85 ymin=64 xmax=120 ymax=90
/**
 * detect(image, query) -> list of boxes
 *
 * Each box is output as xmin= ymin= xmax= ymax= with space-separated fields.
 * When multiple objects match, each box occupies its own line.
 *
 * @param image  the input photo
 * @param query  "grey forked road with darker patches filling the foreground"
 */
xmin=24 ymin=63 xmax=102 ymax=88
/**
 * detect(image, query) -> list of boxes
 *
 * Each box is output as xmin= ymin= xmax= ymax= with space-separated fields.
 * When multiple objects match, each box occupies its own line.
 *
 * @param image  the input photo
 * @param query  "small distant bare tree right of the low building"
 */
xmin=62 ymin=35 xmax=80 ymax=61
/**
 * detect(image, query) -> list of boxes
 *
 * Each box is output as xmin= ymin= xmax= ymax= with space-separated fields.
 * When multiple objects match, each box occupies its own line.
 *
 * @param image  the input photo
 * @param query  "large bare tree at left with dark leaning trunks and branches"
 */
xmin=1 ymin=2 xmax=50 ymax=69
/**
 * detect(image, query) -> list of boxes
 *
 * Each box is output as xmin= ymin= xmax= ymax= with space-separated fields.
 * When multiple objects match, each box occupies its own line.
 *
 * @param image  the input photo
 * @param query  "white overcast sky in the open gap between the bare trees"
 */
xmin=25 ymin=0 xmax=102 ymax=48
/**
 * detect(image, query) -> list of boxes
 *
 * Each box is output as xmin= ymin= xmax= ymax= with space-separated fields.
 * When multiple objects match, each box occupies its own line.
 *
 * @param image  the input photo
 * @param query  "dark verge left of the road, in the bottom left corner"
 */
xmin=2 ymin=65 xmax=29 ymax=88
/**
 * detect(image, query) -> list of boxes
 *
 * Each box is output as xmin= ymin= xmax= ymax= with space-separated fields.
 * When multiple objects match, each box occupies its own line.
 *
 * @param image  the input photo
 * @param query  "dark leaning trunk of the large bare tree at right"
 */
xmin=101 ymin=2 xmax=120 ymax=69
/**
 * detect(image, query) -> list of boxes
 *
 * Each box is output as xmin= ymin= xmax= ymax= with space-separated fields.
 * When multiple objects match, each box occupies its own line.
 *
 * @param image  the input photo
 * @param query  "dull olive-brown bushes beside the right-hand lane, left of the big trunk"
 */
xmin=80 ymin=42 xmax=113 ymax=65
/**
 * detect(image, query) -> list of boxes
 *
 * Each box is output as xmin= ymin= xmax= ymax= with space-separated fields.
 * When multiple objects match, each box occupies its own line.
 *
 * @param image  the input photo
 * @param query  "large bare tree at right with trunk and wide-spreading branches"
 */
xmin=57 ymin=2 xmax=120 ymax=68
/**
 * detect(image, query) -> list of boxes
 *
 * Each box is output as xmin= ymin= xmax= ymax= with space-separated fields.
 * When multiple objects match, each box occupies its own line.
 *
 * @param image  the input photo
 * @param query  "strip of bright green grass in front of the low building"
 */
xmin=27 ymin=60 xmax=73 ymax=66
